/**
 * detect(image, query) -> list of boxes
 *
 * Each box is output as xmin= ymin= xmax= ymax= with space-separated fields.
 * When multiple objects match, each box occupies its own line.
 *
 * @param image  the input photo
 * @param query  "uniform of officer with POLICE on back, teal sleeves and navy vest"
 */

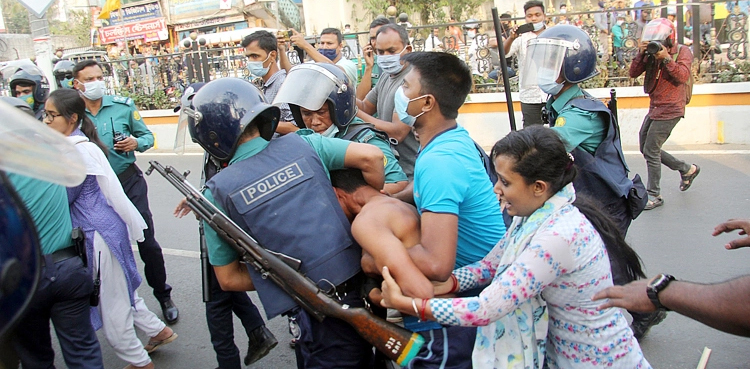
xmin=205 ymin=130 xmax=372 ymax=368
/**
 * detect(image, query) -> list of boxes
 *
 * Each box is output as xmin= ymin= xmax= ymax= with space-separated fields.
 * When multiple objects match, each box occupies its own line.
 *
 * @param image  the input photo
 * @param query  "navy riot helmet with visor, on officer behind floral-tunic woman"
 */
xmin=521 ymin=24 xmax=599 ymax=93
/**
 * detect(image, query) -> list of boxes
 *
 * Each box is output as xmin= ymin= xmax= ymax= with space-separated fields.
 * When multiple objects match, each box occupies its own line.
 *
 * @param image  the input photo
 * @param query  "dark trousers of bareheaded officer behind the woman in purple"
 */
xmin=120 ymin=163 xmax=172 ymax=302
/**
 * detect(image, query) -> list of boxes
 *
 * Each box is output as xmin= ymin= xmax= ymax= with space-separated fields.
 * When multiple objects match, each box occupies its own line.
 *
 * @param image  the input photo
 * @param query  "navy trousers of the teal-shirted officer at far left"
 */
xmin=13 ymin=256 xmax=104 ymax=369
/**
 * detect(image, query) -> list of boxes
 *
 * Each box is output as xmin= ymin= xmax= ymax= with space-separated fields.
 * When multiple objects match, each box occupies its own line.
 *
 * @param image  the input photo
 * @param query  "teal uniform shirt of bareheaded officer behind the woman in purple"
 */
xmin=86 ymin=95 xmax=154 ymax=174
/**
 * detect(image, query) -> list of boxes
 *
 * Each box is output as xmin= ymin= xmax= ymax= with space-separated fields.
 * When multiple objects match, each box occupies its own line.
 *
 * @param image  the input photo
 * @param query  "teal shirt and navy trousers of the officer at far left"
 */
xmin=8 ymin=174 xmax=103 ymax=368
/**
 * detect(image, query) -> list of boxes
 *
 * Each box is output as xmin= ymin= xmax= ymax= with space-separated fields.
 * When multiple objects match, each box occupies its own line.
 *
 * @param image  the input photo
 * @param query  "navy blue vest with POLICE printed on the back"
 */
xmin=207 ymin=134 xmax=362 ymax=319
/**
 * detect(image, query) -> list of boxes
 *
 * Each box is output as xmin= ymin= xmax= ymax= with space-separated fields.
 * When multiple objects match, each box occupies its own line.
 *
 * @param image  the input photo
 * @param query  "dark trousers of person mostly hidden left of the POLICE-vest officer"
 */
xmin=206 ymin=268 xmax=265 ymax=369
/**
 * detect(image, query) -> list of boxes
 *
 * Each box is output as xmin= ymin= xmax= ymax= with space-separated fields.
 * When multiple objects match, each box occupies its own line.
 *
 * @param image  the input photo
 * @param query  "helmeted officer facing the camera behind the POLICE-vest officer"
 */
xmin=273 ymin=63 xmax=408 ymax=193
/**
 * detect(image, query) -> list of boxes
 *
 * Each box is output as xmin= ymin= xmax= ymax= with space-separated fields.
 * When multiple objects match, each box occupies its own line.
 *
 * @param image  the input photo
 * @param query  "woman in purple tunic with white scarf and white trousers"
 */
xmin=44 ymin=90 xmax=177 ymax=368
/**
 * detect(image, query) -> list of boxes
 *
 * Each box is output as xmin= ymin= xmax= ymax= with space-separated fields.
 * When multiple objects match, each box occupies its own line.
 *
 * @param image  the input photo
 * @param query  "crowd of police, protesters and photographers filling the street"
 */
xmin=0 ymin=1 xmax=750 ymax=369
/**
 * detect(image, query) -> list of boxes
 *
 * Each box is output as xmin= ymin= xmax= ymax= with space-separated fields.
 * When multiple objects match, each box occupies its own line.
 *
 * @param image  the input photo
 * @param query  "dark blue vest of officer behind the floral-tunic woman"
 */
xmin=550 ymin=91 xmax=633 ymax=205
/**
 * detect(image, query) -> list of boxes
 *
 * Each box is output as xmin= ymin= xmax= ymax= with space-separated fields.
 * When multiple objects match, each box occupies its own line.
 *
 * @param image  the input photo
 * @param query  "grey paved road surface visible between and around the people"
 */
xmin=48 ymin=146 xmax=750 ymax=368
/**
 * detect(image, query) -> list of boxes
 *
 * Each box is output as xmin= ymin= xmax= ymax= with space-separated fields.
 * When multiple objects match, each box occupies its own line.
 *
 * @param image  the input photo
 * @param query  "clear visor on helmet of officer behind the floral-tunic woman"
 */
xmin=520 ymin=38 xmax=573 ymax=88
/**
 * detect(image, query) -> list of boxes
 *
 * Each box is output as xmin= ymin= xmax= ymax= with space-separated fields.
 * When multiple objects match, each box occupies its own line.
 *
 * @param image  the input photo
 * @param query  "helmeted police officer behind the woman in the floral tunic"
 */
xmin=525 ymin=25 xmax=666 ymax=339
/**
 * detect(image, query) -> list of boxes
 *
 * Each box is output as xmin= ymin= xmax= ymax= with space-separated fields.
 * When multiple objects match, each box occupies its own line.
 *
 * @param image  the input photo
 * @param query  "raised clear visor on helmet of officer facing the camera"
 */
xmin=273 ymin=63 xmax=348 ymax=111
